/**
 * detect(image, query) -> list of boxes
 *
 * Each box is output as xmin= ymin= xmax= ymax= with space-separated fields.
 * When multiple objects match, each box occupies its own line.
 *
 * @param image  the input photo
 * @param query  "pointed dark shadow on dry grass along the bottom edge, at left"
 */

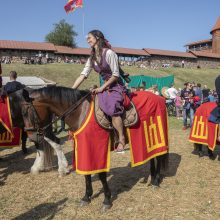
xmin=13 ymin=198 xmax=68 ymax=220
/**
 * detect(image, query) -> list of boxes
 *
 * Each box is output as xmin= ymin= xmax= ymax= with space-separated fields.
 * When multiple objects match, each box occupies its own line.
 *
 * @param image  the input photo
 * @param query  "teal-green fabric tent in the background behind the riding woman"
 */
xmin=100 ymin=75 xmax=174 ymax=93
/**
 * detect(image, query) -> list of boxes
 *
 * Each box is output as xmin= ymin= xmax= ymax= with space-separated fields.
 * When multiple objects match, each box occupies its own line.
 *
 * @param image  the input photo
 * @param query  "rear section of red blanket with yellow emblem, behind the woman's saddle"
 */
xmin=127 ymin=91 xmax=168 ymax=167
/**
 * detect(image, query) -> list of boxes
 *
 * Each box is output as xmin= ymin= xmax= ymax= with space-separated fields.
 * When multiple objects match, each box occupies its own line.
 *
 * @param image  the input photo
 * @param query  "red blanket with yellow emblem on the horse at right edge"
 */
xmin=189 ymin=102 xmax=219 ymax=151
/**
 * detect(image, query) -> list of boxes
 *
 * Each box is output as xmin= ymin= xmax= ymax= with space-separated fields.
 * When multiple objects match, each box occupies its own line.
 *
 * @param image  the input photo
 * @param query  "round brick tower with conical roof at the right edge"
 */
xmin=210 ymin=17 xmax=220 ymax=53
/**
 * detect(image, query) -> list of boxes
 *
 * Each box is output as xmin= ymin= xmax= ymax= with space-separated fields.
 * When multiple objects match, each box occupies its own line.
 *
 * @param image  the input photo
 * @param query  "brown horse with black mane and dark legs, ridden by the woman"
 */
xmin=22 ymin=87 xmax=168 ymax=209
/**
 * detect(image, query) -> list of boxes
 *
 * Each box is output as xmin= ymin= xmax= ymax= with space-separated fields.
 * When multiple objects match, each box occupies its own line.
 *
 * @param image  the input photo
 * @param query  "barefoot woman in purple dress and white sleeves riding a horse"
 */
xmin=72 ymin=30 xmax=126 ymax=152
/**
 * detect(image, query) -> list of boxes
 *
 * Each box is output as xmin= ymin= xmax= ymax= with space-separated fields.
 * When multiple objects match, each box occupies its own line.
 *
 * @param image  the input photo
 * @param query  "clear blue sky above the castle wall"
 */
xmin=0 ymin=0 xmax=220 ymax=51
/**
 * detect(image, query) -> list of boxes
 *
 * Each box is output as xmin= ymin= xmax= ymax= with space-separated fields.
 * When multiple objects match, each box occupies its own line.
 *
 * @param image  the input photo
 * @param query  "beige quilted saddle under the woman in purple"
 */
xmin=94 ymin=95 xmax=139 ymax=130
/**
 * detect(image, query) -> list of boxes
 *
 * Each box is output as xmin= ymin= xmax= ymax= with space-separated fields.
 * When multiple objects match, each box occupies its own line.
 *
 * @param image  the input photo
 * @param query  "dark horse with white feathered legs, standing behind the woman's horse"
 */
xmin=0 ymin=89 xmax=68 ymax=175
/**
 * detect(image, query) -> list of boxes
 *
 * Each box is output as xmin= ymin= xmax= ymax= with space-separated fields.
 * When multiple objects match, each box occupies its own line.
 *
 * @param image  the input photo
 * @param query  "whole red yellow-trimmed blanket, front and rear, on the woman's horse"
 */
xmin=73 ymin=91 xmax=168 ymax=175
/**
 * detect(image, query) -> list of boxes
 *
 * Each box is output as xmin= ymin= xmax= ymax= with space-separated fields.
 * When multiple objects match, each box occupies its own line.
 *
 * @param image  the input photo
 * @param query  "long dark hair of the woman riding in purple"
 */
xmin=88 ymin=30 xmax=111 ymax=65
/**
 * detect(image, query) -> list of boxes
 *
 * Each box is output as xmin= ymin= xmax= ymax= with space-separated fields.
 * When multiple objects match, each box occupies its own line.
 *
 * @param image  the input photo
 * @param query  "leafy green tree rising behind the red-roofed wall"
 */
xmin=45 ymin=19 xmax=78 ymax=47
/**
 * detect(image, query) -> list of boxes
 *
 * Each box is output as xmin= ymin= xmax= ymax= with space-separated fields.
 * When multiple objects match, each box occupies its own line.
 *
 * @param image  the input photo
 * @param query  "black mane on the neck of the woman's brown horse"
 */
xmin=30 ymin=86 xmax=89 ymax=104
